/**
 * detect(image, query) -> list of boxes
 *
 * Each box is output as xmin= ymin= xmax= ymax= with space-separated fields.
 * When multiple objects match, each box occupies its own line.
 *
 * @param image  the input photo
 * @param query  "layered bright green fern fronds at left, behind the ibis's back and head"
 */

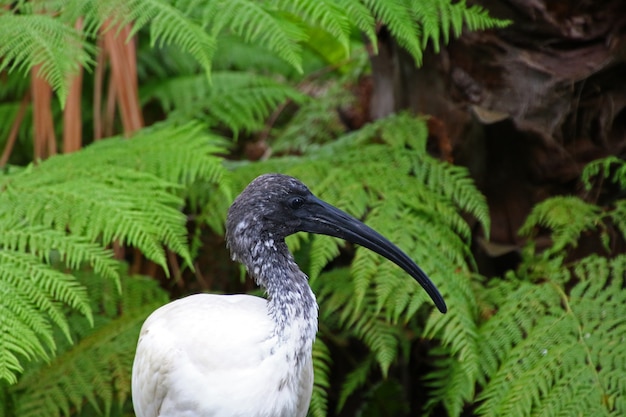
xmin=0 ymin=124 xmax=223 ymax=383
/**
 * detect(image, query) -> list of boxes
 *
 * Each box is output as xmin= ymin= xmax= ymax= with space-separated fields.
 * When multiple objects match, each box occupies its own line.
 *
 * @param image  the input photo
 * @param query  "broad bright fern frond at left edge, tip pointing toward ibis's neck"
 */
xmin=0 ymin=166 xmax=190 ymax=268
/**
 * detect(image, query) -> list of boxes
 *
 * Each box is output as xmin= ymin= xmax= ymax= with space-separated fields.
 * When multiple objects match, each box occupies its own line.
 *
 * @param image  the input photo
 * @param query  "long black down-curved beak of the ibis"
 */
xmin=299 ymin=196 xmax=448 ymax=313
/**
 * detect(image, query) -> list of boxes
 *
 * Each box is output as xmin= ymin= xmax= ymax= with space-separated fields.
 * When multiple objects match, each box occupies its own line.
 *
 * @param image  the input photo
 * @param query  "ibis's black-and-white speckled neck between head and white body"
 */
xmin=248 ymin=238 xmax=317 ymax=356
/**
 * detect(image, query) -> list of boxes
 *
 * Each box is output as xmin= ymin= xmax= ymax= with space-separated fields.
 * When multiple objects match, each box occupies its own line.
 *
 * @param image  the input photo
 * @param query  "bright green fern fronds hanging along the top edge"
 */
xmin=0 ymin=0 xmax=507 ymax=109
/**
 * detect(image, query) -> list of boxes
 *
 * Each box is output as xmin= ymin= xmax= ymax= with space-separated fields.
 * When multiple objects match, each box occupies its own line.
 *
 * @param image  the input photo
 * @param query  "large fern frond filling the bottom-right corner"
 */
xmin=477 ymin=256 xmax=626 ymax=416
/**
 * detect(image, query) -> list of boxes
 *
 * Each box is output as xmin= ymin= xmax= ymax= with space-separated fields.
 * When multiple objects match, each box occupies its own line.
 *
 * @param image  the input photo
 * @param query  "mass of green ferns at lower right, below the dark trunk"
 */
xmin=427 ymin=158 xmax=626 ymax=416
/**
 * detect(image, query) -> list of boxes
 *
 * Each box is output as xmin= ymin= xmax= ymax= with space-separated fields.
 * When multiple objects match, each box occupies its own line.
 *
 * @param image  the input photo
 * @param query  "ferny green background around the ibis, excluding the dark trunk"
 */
xmin=0 ymin=0 xmax=626 ymax=417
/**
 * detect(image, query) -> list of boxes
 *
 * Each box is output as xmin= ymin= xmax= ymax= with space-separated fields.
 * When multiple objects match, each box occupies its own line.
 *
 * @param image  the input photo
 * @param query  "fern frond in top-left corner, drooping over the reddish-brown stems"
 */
xmin=0 ymin=13 xmax=94 ymax=105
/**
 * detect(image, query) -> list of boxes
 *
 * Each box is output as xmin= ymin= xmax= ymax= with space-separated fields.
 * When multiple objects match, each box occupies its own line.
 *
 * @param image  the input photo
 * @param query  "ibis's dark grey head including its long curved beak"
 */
xmin=226 ymin=174 xmax=447 ymax=313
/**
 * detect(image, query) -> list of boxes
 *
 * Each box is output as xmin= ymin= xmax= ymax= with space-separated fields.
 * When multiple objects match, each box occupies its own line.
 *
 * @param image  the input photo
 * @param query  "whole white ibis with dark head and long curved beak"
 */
xmin=132 ymin=174 xmax=446 ymax=417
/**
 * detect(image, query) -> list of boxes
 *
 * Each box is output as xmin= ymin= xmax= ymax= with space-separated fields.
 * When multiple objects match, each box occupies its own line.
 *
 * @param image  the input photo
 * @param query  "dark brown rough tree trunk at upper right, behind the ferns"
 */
xmin=371 ymin=0 xmax=626 ymax=272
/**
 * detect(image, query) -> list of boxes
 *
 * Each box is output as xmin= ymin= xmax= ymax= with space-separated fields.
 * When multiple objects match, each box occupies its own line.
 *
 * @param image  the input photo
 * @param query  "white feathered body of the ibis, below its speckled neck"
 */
xmin=132 ymin=294 xmax=317 ymax=417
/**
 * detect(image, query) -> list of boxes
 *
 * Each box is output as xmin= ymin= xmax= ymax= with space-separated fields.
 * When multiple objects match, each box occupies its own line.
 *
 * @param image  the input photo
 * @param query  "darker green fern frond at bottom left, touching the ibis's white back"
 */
xmin=12 ymin=276 xmax=166 ymax=417
